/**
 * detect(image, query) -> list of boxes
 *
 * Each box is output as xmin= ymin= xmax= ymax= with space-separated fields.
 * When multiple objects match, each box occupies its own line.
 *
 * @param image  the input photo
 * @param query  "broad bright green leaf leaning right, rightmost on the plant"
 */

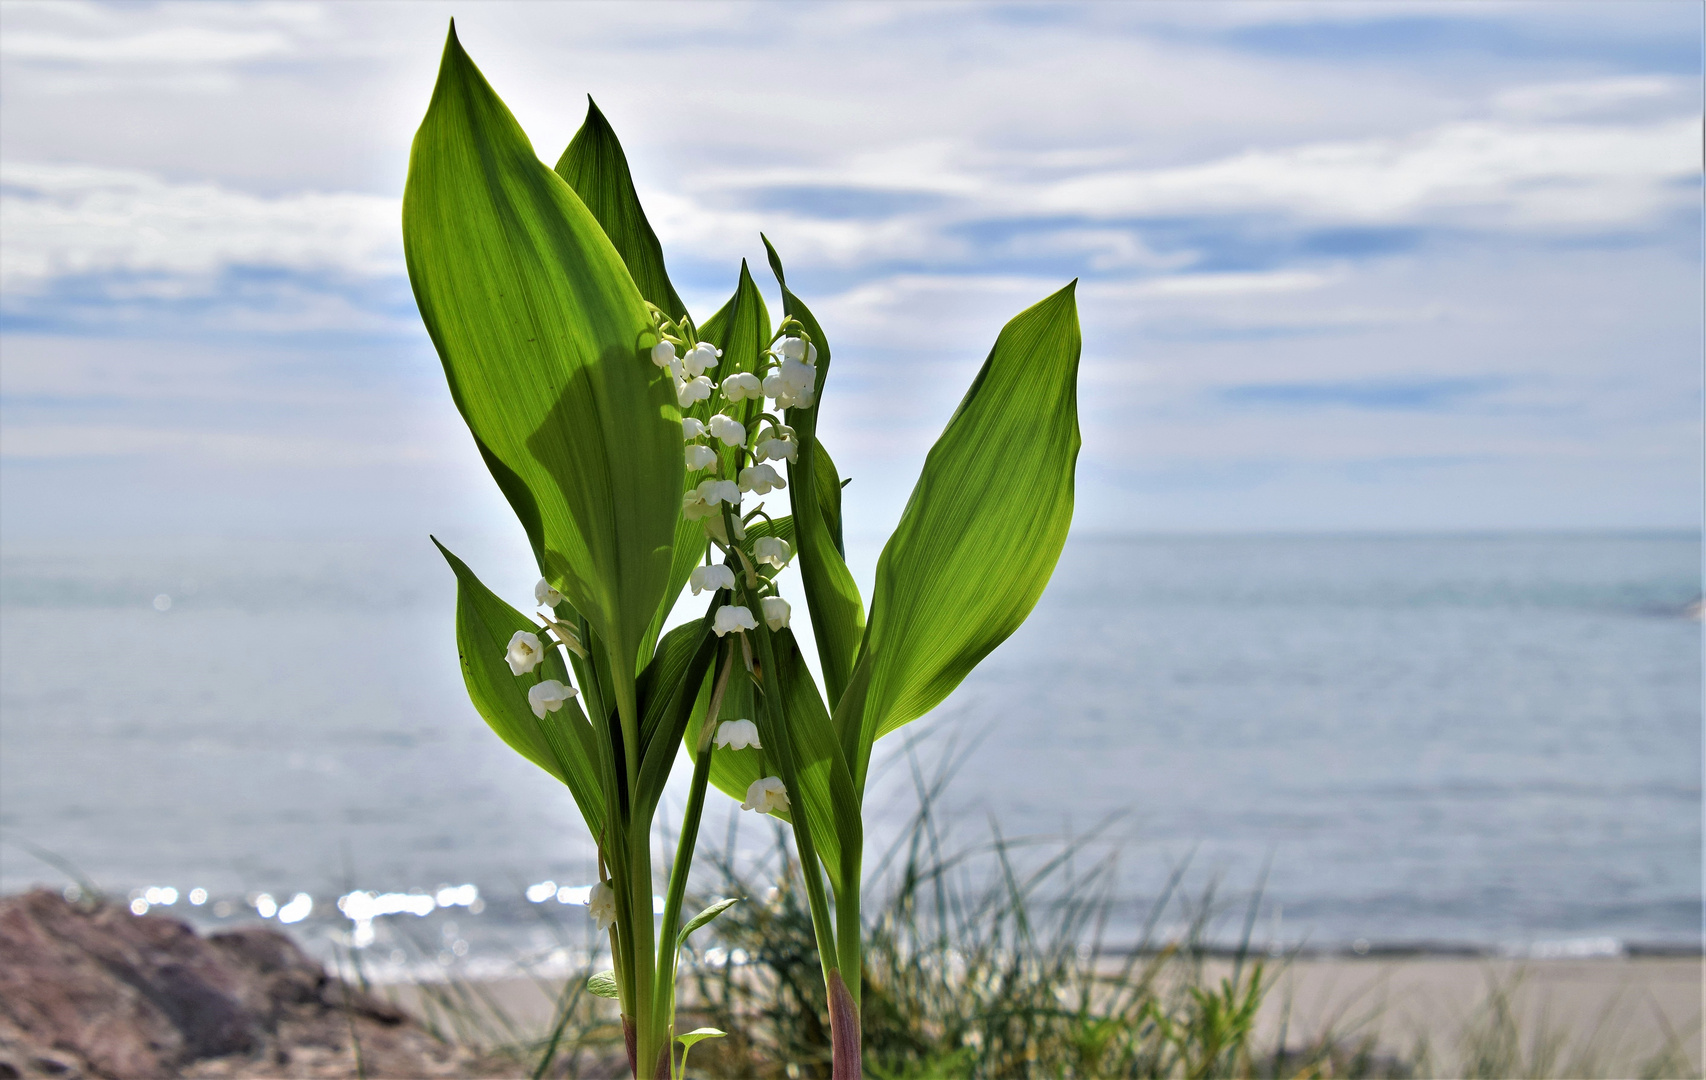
xmin=838 ymin=282 xmax=1080 ymax=790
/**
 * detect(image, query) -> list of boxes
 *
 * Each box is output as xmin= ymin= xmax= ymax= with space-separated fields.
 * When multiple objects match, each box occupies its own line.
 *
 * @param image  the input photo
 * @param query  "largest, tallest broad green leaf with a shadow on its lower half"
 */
xmin=403 ymin=27 xmax=682 ymax=686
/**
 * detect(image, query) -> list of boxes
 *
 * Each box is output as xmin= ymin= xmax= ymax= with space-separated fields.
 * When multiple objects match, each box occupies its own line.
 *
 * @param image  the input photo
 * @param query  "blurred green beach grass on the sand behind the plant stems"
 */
xmin=342 ymin=740 xmax=1701 ymax=1080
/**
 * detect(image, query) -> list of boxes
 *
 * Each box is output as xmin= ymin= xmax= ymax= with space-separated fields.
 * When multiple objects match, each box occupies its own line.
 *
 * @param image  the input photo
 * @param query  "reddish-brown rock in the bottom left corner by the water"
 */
xmin=0 ymin=889 xmax=491 ymax=1080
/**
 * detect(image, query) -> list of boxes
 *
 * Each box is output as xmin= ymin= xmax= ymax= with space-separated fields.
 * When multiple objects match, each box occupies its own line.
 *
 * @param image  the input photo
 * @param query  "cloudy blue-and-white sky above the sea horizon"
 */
xmin=0 ymin=0 xmax=1703 ymax=556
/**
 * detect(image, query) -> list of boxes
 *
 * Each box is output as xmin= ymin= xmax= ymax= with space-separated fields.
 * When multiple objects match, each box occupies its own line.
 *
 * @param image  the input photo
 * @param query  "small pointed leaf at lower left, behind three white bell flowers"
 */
xmin=433 ymin=539 xmax=604 ymax=836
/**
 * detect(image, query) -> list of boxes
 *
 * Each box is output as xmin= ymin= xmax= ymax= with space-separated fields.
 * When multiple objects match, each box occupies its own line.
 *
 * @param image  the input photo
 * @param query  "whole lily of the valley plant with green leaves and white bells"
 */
xmin=403 ymin=27 xmax=1080 ymax=1080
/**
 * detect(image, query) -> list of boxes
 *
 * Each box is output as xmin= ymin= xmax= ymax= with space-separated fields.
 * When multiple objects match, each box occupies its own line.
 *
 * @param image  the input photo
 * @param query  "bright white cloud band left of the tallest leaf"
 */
xmin=0 ymin=162 xmax=403 ymax=293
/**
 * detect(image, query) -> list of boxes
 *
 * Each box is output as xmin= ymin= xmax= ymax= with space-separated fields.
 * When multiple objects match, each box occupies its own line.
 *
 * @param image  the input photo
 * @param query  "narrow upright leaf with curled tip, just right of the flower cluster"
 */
xmin=764 ymin=237 xmax=865 ymax=706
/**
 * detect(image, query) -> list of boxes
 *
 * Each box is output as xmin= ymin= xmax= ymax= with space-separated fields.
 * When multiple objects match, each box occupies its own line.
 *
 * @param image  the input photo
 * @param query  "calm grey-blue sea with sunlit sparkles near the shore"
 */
xmin=0 ymin=532 xmax=1703 ymax=978
